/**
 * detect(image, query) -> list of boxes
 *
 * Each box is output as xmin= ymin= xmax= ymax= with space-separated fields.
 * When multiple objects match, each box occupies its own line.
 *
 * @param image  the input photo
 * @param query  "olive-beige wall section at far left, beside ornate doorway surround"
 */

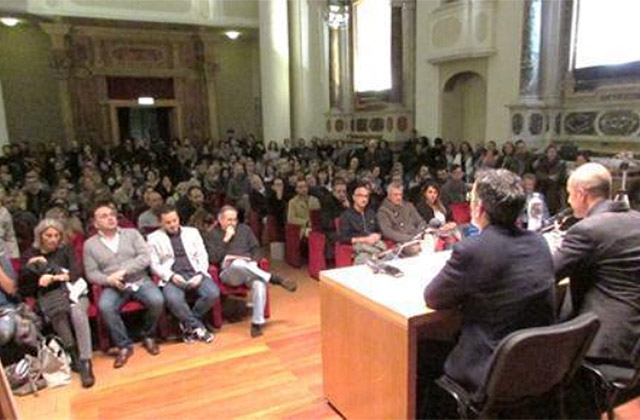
xmin=0 ymin=24 xmax=64 ymax=147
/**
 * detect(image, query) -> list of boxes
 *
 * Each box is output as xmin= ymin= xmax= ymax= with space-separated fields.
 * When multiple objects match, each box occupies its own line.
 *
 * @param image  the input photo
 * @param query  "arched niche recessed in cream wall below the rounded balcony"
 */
xmin=442 ymin=72 xmax=487 ymax=143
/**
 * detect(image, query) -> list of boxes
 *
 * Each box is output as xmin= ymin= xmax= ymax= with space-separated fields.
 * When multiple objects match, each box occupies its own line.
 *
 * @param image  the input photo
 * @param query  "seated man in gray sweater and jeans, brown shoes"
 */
xmin=84 ymin=201 xmax=164 ymax=368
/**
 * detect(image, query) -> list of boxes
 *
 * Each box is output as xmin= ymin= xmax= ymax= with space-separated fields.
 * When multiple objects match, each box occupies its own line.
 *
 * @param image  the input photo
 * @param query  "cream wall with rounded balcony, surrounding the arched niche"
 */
xmin=416 ymin=1 xmax=524 ymax=142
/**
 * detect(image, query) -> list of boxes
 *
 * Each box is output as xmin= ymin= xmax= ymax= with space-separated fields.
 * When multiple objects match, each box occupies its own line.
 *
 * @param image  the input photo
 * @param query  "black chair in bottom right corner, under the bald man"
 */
xmin=583 ymin=341 xmax=640 ymax=420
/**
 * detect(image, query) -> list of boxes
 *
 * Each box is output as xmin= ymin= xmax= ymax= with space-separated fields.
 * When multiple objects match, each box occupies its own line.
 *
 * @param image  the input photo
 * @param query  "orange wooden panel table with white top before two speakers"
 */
xmin=320 ymin=252 xmax=459 ymax=419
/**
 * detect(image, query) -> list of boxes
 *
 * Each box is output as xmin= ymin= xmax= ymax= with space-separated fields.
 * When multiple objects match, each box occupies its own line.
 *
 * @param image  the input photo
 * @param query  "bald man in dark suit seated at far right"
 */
xmin=553 ymin=163 xmax=640 ymax=364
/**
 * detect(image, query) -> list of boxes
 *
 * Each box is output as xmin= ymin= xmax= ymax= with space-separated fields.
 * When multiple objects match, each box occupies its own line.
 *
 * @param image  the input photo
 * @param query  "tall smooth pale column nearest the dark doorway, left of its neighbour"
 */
xmin=259 ymin=0 xmax=291 ymax=143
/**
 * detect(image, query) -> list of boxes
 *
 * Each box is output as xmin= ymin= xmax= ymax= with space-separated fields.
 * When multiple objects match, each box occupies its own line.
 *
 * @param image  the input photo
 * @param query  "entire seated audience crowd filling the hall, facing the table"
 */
xmin=0 ymin=131 xmax=612 ymax=400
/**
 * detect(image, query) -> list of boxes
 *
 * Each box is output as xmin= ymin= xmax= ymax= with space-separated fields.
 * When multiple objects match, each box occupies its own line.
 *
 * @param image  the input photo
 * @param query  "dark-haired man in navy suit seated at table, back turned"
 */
xmin=424 ymin=169 xmax=555 ymax=412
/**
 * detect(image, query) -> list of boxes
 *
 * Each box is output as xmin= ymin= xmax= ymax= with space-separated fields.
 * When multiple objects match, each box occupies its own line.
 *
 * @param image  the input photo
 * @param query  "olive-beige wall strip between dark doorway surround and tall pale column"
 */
xmin=212 ymin=40 xmax=262 ymax=137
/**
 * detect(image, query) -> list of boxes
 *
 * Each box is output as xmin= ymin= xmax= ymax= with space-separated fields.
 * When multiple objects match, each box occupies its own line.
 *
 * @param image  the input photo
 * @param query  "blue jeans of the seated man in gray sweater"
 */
xmin=98 ymin=279 xmax=164 ymax=348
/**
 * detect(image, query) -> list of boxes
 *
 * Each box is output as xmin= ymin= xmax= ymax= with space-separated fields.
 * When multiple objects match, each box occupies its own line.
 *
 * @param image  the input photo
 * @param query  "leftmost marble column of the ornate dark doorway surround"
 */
xmin=40 ymin=23 xmax=76 ymax=145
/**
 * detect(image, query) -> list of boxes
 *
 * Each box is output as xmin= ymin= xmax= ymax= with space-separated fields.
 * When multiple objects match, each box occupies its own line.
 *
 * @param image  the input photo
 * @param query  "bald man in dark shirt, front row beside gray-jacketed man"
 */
xmin=340 ymin=184 xmax=386 ymax=264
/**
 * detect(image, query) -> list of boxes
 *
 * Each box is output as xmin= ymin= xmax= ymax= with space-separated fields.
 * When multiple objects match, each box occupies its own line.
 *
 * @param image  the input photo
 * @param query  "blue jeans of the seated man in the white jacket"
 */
xmin=162 ymin=276 xmax=220 ymax=330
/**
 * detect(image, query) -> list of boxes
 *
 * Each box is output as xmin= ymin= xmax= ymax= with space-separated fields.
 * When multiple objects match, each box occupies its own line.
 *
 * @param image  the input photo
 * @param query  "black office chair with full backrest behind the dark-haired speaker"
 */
xmin=436 ymin=313 xmax=600 ymax=419
